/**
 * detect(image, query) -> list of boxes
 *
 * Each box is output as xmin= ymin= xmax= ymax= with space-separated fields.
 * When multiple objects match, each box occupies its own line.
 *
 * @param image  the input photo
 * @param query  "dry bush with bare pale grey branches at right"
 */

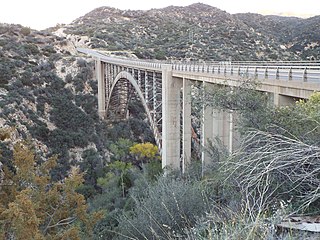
xmin=225 ymin=130 xmax=320 ymax=213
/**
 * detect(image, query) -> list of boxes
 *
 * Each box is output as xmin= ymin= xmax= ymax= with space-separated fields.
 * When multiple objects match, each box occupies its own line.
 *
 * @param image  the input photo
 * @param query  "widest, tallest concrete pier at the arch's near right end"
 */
xmin=162 ymin=64 xmax=182 ymax=169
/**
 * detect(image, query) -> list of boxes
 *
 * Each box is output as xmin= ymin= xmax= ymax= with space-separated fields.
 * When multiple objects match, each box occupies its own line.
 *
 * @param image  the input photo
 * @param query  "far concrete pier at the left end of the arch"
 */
xmin=95 ymin=59 xmax=106 ymax=119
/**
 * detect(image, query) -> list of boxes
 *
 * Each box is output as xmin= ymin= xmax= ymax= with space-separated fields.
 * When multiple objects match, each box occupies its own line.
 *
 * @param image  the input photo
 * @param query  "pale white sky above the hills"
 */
xmin=0 ymin=0 xmax=320 ymax=30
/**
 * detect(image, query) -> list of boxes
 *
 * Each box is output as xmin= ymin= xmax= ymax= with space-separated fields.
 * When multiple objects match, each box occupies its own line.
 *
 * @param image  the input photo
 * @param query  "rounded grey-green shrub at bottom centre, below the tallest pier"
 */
xmin=116 ymin=177 xmax=212 ymax=239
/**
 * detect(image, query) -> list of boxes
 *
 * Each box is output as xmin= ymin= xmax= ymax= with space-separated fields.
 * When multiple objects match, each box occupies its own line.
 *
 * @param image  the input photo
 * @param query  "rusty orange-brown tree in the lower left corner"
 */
xmin=0 ymin=142 xmax=102 ymax=240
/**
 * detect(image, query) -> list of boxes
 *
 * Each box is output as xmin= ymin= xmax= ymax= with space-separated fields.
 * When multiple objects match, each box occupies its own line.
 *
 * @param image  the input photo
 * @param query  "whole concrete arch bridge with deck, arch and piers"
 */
xmin=78 ymin=48 xmax=320 ymax=172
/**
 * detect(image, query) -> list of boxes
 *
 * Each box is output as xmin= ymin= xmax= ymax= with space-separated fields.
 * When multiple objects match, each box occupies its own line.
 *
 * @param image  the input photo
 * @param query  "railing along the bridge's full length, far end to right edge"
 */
xmin=77 ymin=48 xmax=320 ymax=83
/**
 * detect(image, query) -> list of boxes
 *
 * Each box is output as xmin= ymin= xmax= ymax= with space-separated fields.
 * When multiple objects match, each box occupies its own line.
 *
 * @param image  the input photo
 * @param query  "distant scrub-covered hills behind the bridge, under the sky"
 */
xmin=63 ymin=3 xmax=320 ymax=60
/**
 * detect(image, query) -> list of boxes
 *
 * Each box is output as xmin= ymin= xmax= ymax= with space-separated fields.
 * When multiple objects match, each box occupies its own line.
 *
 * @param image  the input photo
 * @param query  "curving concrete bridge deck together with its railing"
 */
xmin=78 ymin=48 xmax=320 ymax=98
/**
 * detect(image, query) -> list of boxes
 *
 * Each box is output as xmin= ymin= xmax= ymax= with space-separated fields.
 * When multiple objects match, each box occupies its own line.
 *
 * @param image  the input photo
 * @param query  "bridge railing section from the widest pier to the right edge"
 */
xmin=172 ymin=62 xmax=320 ymax=83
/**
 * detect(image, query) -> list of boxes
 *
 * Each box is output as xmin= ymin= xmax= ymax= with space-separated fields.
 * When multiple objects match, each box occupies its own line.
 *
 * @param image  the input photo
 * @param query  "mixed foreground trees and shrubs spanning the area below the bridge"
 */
xmin=0 ymin=89 xmax=320 ymax=239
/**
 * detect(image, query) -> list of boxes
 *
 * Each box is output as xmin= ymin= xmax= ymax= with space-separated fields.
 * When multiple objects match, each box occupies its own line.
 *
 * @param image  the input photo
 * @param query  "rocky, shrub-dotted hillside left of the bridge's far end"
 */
xmin=0 ymin=24 xmax=152 ymax=182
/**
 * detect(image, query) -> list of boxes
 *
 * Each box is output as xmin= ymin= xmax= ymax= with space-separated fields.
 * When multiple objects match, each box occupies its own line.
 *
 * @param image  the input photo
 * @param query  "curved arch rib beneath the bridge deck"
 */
xmin=106 ymin=71 xmax=162 ymax=152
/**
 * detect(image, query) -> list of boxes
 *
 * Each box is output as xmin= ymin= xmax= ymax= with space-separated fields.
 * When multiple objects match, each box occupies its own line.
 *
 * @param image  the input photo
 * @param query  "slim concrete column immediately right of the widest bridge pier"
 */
xmin=182 ymin=78 xmax=192 ymax=173
